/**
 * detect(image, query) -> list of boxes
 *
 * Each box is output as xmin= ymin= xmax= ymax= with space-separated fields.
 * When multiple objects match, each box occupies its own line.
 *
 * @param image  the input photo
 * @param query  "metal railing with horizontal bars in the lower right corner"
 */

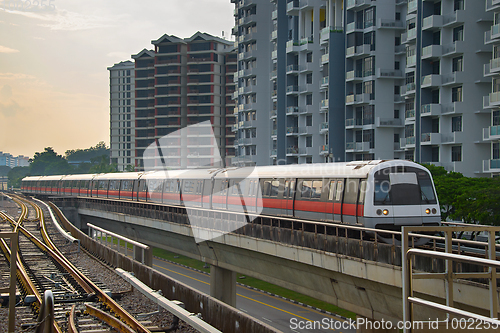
xmin=401 ymin=223 xmax=500 ymax=333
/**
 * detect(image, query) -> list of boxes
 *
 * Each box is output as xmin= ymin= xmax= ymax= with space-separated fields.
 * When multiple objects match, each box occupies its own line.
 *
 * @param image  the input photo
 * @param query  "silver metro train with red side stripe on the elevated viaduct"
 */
xmin=22 ymin=160 xmax=441 ymax=231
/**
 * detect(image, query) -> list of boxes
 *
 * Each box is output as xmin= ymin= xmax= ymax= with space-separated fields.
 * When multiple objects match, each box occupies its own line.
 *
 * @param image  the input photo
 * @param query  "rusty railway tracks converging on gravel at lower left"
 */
xmin=0 ymin=196 xmax=162 ymax=333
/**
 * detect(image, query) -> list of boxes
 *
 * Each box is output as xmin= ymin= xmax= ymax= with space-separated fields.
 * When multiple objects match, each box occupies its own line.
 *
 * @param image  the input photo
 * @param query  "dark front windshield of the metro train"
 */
xmin=374 ymin=167 xmax=437 ymax=205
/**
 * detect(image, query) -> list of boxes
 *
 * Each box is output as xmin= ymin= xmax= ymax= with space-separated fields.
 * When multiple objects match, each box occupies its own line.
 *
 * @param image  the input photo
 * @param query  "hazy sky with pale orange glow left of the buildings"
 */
xmin=0 ymin=0 xmax=234 ymax=157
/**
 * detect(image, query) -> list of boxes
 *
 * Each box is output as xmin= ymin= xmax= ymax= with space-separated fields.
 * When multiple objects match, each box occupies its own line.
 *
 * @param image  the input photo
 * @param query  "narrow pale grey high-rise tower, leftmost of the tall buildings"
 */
xmin=108 ymin=61 xmax=135 ymax=171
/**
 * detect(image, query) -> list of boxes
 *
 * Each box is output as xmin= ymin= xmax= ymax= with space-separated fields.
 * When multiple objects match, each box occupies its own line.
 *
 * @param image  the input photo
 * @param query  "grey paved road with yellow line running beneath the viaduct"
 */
xmin=153 ymin=258 xmax=356 ymax=333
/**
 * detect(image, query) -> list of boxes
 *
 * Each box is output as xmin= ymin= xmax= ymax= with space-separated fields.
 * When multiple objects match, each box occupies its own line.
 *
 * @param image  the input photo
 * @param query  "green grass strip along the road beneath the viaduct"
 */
xmin=153 ymin=248 xmax=356 ymax=320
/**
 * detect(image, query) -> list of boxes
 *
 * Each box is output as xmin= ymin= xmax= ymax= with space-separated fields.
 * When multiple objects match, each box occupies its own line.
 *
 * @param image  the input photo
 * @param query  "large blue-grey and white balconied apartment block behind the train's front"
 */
xmin=231 ymin=0 xmax=492 ymax=176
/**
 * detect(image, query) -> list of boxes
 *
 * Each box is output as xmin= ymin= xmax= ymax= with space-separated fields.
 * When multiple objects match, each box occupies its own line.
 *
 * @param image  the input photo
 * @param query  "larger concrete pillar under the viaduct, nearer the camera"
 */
xmin=210 ymin=265 xmax=236 ymax=307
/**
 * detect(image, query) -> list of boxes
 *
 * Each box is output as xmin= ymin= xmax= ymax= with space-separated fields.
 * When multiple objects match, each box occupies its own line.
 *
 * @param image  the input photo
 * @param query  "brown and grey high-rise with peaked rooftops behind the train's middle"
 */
xmin=132 ymin=32 xmax=236 ymax=170
